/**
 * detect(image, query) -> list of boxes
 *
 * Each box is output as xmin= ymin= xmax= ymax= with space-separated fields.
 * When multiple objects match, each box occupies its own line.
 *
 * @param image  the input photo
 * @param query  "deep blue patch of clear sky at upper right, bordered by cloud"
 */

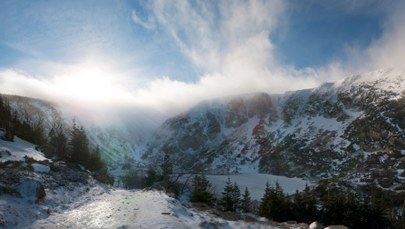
xmin=271 ymin=1 xmax=385 ymax=68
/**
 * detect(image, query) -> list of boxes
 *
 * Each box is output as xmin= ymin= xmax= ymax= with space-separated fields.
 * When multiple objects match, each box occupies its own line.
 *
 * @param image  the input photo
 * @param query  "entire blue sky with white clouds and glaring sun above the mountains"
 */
xmin=0 ymin=0 xmax=405 ymax=125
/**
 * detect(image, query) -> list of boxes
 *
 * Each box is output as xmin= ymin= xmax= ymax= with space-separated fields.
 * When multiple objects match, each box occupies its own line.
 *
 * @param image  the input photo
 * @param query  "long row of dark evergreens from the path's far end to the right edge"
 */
xmin=118 ymin=150 xmax=405 ymax=228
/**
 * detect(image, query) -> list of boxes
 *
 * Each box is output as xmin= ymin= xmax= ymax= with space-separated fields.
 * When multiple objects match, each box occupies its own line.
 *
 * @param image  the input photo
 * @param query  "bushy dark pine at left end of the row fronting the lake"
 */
xmin=190 ymin=175 xmax=214 ymax=205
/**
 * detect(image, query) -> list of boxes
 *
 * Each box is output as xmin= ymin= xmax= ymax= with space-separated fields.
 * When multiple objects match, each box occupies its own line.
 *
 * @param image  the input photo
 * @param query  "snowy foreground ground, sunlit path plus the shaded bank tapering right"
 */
xmin=27 ymin=190 xmax=288 ymax=229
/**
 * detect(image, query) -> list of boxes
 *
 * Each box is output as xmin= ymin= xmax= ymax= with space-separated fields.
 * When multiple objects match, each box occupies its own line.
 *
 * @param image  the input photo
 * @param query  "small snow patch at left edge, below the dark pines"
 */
xmin=0 ymin=137 xmax=48 ymax=162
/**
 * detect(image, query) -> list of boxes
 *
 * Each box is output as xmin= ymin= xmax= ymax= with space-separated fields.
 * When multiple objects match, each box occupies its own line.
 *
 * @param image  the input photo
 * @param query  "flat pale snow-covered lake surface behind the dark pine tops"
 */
xmin=206 ymin=174 xmax=310 ymax=200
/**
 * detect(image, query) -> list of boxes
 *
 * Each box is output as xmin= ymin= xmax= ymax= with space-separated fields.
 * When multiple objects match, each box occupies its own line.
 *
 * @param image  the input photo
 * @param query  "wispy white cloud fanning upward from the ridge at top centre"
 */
xmin=125 ymin=0 xmax=320 ymax=115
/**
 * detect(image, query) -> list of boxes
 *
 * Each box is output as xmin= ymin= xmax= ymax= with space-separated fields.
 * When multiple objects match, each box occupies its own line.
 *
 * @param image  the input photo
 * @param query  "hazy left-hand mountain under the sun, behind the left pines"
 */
xmin=4 ymin=95 xmax=147 ymax=165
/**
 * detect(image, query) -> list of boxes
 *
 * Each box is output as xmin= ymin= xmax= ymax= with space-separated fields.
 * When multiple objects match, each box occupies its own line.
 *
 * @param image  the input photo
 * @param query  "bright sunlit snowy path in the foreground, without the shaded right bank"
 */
xmin=33 ymin=190 xmax=193 ymax=228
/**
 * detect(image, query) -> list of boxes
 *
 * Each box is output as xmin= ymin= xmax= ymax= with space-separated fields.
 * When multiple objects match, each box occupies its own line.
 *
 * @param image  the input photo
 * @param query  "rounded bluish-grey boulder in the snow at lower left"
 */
xmin=17 ymin=179 xmax=46 ymax=203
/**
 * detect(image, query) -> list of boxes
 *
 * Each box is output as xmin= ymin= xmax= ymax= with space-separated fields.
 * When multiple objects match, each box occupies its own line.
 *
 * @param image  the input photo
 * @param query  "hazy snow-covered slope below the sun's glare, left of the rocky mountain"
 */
xmin=1 ymin=95 xmax=153 ymax=166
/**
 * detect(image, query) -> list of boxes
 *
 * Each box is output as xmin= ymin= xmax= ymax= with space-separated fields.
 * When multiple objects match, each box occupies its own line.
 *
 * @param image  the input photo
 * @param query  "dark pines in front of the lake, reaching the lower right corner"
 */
xmin=190 ymin=175 xmax=405 ymax=228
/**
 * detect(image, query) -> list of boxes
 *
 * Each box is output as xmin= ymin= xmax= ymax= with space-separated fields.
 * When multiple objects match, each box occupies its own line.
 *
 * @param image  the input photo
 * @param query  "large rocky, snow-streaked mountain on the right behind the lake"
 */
xmin=142 ymin=69 xmax=405 ymax=190
